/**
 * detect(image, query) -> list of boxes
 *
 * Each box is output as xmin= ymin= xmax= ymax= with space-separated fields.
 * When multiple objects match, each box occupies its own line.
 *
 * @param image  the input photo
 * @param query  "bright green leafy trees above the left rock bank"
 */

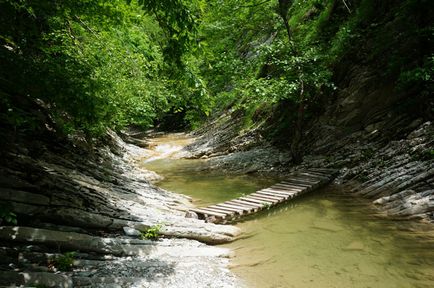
xmin=0 ymin=0 xmax=208 ymax=137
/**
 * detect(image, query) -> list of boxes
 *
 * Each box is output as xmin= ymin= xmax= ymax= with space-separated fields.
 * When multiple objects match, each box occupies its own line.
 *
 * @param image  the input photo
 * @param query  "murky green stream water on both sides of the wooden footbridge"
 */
xmin=145 ymin=135 xmax=434 ymax=288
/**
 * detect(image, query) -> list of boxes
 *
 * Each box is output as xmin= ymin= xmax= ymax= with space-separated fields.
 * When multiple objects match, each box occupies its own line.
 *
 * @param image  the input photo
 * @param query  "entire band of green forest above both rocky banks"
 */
xmin=0 ymin=0 xmax=434 ymax=148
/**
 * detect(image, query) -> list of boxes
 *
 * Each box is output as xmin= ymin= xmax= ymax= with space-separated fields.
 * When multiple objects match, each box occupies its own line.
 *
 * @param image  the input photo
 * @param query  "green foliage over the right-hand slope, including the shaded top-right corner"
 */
xmin=199 ymin=0 xmax=434 ymax=146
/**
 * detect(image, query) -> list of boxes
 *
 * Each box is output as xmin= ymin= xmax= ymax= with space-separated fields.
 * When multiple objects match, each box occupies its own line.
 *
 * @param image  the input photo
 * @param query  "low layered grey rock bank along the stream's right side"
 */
xmin=187 ymin=114 xmax=434 ymax=222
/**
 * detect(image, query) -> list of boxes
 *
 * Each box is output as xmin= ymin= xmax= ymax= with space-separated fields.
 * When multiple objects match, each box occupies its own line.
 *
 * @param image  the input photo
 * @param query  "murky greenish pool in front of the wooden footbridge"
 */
xmin=228 ymin=188 xmax=434 ymax=287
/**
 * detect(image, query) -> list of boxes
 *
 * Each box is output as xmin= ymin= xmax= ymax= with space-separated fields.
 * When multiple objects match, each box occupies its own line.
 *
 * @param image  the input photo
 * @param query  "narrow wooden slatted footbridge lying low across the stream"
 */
xmin=190 ymin=168 xmax=337 ymax=223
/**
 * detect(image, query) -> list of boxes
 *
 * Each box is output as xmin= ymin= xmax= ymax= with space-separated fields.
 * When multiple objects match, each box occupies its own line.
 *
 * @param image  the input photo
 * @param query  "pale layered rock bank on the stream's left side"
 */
xmin=0 ymin=133 xmax=241 ymax=287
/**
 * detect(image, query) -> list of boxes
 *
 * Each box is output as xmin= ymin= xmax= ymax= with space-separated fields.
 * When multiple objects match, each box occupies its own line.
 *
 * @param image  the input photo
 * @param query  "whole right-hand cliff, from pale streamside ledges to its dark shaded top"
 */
xmin=182 ymin=1 xmax=434 ymax=221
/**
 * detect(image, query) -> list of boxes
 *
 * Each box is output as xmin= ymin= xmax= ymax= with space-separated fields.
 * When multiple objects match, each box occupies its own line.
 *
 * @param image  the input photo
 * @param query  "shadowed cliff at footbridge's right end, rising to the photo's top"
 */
xmin=298 ymin=1 xmax=434 ymax=221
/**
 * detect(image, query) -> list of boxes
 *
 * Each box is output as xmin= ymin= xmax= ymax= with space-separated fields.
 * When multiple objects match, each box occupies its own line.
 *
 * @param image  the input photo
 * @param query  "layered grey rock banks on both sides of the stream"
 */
xmin=0 ymin=109 xmax=434 ymax=287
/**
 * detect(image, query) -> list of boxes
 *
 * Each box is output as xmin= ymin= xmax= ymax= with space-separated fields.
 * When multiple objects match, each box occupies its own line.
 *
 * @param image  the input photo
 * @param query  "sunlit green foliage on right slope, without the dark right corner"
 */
xmin=196 ymin=1 xmax=335 ymax=136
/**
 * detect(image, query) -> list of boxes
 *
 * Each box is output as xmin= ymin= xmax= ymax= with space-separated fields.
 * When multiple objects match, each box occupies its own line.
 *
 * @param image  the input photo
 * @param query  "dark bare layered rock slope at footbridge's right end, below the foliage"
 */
xmin=304 ymin=56 xmax=434 ymax=221
